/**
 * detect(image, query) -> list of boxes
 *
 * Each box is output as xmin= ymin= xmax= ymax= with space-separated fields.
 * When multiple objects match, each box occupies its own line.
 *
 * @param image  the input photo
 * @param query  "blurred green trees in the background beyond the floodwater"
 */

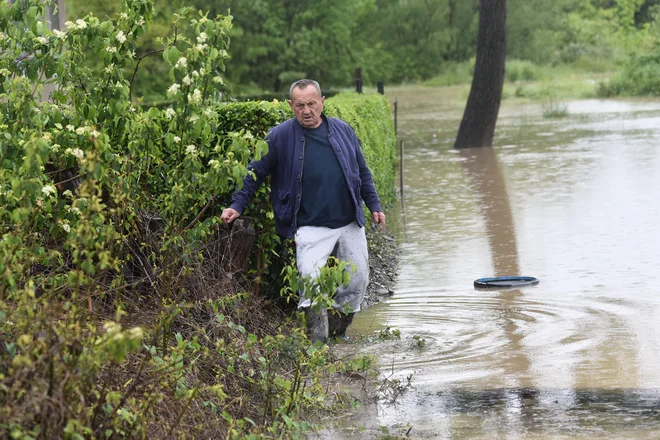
xmin=59 ymin=0 xmax=660 ymax=92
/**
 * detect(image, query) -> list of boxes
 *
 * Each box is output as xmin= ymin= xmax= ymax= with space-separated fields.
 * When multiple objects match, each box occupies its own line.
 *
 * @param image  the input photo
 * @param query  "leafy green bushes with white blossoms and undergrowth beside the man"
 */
xmin=0 ymin=0 xmax=392 ymax=439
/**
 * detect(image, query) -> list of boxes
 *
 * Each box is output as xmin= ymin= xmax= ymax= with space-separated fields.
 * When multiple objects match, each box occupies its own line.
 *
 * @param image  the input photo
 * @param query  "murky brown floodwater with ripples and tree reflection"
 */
xmin=332 ymin=89 xmax=660 ymax=439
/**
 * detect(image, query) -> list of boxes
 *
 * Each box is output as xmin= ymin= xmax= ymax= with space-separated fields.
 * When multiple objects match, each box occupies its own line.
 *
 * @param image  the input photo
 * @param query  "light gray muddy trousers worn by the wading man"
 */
xmin=295 ymin=222 xmax=369 ymax=312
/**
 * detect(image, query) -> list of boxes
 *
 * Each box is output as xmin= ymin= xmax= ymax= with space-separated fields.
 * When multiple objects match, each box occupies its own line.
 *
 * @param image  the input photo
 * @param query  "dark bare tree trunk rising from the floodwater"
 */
xmin=454 ymin=0 xmax=506 ymax=148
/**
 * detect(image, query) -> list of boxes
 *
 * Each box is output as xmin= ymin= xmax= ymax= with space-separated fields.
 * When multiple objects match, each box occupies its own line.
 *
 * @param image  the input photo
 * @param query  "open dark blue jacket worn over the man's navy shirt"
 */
xmin=231 ymin=116 xmax=382 ymax=238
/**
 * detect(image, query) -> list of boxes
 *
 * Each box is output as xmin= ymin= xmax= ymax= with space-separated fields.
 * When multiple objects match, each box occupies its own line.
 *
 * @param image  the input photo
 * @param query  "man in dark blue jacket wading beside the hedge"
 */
xmin=221 ymin=79 xmax=385 ymax=342
